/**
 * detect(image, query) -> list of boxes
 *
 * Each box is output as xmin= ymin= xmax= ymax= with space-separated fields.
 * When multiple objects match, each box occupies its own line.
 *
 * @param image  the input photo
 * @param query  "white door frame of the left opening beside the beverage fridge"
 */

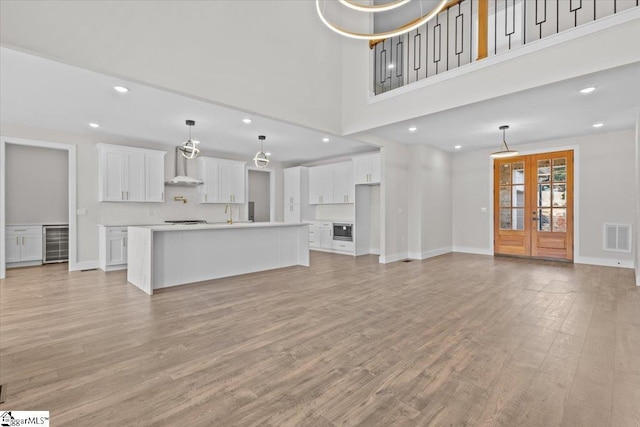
xmin=0 ymin=136 xmax=79 ymax=279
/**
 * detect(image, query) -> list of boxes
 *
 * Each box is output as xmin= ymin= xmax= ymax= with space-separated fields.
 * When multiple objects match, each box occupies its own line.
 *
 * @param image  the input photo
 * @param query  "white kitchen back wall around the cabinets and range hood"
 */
xmin=2 ymin=125 xmax=284 ymax=266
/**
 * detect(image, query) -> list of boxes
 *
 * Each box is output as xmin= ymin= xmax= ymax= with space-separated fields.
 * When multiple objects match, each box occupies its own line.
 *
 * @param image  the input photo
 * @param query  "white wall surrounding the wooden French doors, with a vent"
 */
xmin=453 ymin=131 xmax=636 ymax=267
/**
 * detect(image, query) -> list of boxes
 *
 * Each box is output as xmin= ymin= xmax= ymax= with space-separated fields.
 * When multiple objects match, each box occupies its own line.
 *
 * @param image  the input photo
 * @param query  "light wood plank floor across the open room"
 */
xmin=0 ymin=252 xmax=640 ymax=427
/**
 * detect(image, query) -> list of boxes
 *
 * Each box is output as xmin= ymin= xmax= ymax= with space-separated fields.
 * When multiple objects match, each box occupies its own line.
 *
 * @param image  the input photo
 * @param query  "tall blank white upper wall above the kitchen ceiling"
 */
xmin=0 ymin=0 xmax=342 ymax=133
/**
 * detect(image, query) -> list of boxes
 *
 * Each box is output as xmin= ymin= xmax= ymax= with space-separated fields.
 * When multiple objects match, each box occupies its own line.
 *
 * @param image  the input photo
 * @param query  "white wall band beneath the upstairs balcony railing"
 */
xmin=342 ymin=8 xmax=640 ymax=135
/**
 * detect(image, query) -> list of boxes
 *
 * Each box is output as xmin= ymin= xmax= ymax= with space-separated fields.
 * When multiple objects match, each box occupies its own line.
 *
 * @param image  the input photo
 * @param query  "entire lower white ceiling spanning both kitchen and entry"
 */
xmin=0 ymin=48 xmax=640 ymax=160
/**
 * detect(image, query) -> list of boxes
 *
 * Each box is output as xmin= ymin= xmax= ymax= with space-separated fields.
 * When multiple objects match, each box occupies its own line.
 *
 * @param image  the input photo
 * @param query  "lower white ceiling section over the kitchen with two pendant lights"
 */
xmin=0 ymin=48 xmax=377 ymax=163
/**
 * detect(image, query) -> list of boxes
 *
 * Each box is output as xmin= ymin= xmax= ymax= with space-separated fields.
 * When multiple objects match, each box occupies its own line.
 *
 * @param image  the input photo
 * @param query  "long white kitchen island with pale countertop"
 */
xmin=127 ymin=222 xmax=309 ymax=295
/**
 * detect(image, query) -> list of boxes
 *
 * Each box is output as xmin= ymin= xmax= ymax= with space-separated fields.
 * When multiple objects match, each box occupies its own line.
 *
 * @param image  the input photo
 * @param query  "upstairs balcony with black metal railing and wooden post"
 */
xmin=369 ymin=0 xmax=640 ymax=95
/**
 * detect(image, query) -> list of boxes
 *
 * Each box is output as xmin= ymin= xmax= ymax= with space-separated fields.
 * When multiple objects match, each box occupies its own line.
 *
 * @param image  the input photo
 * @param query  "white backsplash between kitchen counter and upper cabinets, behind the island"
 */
xmin=98 ymin=187 xmax=247 ymax=225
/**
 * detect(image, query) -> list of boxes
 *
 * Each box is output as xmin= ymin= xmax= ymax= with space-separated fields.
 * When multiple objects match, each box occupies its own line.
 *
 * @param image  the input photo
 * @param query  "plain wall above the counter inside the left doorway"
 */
xmin=5 ymin=144 xmax=69 ymax=224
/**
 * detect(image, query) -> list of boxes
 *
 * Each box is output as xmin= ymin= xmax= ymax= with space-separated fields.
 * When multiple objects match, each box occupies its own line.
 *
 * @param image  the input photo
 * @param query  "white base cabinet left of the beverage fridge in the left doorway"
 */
xmin=5 ymin=225 xmax=42 ymax=267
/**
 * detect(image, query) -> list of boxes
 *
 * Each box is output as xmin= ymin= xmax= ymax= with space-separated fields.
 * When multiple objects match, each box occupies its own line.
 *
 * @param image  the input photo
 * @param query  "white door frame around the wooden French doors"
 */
xmin=487 ymin=145 xmax=581 ymax=264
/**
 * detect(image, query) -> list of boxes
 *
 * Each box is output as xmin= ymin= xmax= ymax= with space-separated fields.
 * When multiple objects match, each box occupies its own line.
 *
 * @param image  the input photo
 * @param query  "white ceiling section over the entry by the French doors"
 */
xmin=371 ymin=62 xmax=640 ymax=151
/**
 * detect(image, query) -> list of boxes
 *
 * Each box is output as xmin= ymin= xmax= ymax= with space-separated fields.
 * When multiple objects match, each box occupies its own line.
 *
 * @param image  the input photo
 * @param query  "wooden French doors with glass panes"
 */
xmin=493 ymin=150 xmax=573 ymax=261
